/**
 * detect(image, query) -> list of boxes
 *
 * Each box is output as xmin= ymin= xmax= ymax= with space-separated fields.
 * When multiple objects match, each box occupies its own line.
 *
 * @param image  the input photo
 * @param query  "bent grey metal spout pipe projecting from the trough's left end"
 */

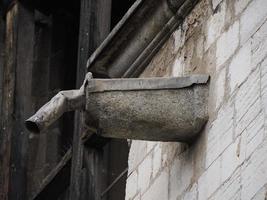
xmin=25 ymin=73 xmax=92 ymax=133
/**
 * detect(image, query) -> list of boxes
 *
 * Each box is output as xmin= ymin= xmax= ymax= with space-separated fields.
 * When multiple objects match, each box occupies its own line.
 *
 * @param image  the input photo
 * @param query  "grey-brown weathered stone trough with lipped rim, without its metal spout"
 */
xmin=86 ymin=75 xmax=208 ymax=142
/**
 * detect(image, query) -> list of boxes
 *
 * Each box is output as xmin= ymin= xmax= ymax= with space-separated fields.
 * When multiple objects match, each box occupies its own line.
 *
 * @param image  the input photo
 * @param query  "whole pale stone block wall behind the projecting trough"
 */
xmin=126 ymin=0 xmax=267 ymax=200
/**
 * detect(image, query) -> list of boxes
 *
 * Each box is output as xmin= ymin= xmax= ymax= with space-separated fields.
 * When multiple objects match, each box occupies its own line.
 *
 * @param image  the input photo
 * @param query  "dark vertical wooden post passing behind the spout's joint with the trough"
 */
xmin=70 ymin=0 xmax=111 ymax=200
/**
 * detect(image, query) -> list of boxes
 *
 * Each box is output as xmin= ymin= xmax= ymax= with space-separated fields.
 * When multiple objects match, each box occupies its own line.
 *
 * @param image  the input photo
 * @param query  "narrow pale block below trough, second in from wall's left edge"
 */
xmin=138 ymin=153 xmax=152 ymax=194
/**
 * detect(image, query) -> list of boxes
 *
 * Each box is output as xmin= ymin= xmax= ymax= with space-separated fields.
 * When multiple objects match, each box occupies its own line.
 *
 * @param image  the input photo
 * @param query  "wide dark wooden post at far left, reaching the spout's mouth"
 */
xmin=0 ymin=3 xmax=34 ymax=200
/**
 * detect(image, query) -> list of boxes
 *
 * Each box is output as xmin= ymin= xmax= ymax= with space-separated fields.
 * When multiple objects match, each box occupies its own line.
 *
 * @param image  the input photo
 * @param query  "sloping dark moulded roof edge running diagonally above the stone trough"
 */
xmin=87 ymin=0 xmax=201 ymax=78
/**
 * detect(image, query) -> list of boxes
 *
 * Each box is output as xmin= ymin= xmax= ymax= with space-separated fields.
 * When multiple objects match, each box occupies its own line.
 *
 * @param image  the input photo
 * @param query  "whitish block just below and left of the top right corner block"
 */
xmin=216 ymin=21 xmax=239 ymax=67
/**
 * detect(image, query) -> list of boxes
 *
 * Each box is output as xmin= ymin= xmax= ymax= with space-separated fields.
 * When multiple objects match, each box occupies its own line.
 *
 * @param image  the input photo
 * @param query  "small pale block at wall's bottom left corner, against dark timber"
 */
xmin=125 ymin=171 xmax=138 ymax=200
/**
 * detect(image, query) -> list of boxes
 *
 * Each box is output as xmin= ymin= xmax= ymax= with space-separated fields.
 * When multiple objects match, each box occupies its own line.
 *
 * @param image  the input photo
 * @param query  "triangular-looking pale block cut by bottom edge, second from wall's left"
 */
xmin=142 ymin=170 xmax=169 ymax=200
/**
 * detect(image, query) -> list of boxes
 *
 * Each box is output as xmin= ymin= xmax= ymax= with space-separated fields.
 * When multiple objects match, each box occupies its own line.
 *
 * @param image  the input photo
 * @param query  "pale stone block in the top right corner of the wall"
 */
xmin=240 ymin=0 xmax=267 ymax=44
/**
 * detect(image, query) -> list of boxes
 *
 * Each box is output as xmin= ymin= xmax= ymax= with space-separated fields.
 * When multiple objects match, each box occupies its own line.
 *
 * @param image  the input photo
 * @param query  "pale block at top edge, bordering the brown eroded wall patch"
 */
xmin=205 ymin=1 xmax=226 ymax=50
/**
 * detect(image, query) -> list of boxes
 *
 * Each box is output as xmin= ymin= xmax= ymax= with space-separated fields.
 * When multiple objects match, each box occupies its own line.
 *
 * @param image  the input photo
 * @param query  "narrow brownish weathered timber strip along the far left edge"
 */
xmin=0 ymin=5 xmax=18 ymax=200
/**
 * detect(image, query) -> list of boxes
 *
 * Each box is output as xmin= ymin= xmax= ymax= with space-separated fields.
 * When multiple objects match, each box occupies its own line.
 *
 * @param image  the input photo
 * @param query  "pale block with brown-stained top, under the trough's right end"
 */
xmin=169 ymin=152 xmax=193 ymax=200
